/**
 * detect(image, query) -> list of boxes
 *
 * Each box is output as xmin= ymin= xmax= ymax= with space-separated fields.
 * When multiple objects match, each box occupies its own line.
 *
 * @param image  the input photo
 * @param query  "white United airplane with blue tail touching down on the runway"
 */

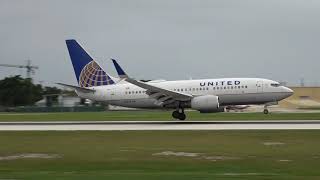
xmin=58 ymin=39 xmax=293 ymax=120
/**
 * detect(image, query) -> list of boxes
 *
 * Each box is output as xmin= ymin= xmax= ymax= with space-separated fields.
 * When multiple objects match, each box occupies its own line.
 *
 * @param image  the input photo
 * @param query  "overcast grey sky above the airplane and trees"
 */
xmin=0 ymin=0 xmax=320 ymax=86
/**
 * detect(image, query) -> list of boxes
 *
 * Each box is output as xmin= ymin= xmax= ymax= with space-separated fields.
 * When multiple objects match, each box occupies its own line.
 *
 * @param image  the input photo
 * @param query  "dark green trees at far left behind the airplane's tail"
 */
xmin=0 ymin=76 xmax=62 ymax=107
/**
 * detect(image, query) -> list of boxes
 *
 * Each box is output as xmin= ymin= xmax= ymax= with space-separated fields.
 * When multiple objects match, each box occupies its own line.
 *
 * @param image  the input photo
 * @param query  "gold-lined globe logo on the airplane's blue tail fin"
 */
xmin=79 ymin=61 xmax=114 ymax=87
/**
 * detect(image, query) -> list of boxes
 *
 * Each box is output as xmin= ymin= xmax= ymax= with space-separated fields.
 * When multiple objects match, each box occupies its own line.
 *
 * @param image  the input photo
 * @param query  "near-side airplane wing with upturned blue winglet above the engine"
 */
xmin=111 ymin=59 xmax=193 ymax=105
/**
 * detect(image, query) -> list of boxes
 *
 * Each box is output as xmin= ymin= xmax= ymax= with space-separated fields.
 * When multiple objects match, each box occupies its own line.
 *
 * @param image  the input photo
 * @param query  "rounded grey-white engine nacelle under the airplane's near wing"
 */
xmin=191 ymin=95 xmax=224 ymax=113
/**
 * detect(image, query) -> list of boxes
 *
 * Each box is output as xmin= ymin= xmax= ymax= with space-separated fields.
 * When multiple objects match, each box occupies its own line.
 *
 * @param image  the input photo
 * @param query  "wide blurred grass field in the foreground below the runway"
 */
xmin=0 ymin=130 xmax=320 ymax=180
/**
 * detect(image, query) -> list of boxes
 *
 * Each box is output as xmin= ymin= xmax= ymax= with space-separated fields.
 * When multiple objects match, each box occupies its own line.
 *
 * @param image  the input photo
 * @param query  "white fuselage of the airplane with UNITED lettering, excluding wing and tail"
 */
xmin=77 ymin=78 xmax=293 ymax=108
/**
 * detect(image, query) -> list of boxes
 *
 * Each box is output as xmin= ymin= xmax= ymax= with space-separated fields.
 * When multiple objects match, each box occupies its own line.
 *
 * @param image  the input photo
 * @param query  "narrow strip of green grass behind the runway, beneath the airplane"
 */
xmin=0 ymin=111 xmax=320 ymax=121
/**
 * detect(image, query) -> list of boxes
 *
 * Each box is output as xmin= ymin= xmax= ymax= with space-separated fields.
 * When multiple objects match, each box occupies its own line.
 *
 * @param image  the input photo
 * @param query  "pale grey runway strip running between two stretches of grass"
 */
xmin=0 ymin=120 xmax=320 ymax=131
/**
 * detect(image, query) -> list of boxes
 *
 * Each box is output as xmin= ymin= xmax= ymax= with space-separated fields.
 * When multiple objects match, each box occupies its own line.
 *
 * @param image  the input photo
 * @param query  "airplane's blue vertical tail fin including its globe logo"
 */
xmin=66 ymin=39 xmax=114 ymax=87
